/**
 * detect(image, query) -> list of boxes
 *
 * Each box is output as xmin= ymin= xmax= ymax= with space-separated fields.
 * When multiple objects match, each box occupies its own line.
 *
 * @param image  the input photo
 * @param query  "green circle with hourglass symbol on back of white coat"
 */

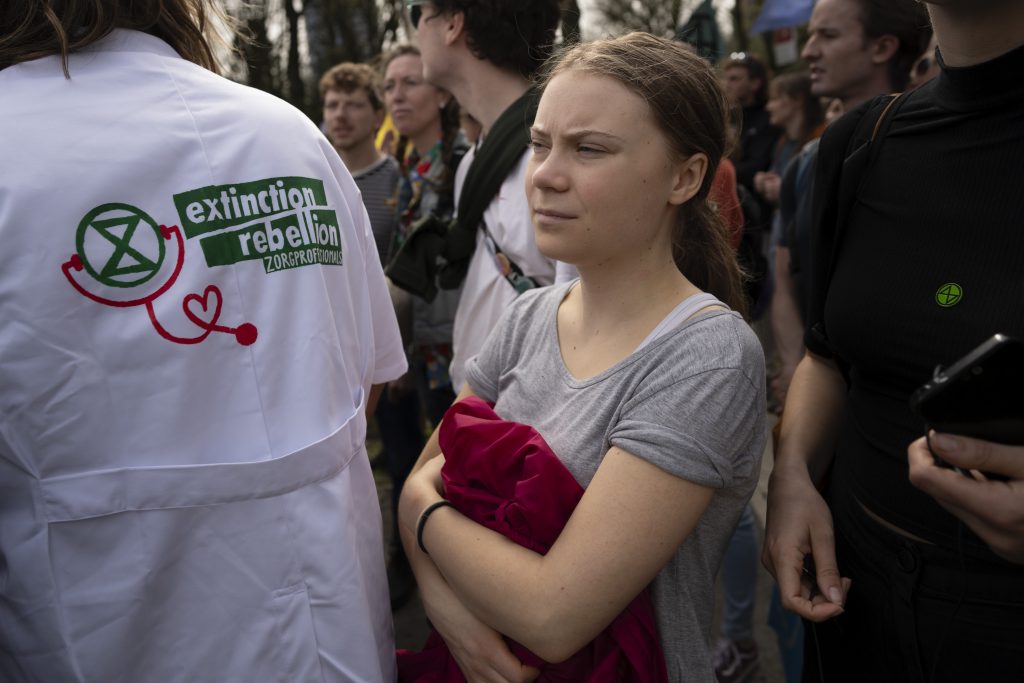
xmin=76 ymin=204 xmax=167 ymax=288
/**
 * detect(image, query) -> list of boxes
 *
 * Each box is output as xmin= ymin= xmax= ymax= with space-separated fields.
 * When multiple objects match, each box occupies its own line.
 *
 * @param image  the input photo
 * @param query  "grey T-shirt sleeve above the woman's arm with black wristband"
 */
xmin=608 ymin=368 xmax=765 ymax=488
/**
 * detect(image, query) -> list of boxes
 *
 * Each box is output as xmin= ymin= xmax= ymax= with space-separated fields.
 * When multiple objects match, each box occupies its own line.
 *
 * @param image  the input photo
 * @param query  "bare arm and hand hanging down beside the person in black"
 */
xmin=763 ymin=352 xmax=849 ymax=622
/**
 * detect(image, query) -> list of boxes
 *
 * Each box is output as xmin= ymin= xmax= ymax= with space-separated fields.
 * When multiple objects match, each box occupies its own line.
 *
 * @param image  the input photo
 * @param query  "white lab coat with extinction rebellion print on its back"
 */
xmin=0 ymin=31 xmax=406 ymax=683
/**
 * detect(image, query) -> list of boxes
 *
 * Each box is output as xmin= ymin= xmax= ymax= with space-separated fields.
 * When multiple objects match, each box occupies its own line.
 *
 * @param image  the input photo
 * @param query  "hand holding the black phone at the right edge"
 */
xmin=907 ymin=432 xmax=1024 ymax=564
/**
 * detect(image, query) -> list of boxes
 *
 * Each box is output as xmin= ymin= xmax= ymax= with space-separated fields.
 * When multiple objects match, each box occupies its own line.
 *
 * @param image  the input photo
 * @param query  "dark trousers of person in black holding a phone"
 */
xmin=804 ymin=485 xmax=1024 ymax=683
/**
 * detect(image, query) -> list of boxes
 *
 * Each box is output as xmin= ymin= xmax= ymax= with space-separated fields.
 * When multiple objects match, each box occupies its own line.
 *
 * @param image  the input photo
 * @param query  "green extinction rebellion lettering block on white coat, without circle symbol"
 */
xmin=174 ymin=176 xmax=342 ymax=272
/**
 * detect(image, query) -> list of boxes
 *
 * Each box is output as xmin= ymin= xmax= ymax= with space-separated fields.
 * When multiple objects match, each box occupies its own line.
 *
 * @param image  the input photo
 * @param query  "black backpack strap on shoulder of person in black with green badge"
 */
xmin=804 ymin=93 xmax=907 ymax=370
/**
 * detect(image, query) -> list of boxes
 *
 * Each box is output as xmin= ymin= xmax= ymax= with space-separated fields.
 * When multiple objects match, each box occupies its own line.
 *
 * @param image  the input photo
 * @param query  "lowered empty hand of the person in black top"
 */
xmin=762 ymin=467 xmax=850 ymax=622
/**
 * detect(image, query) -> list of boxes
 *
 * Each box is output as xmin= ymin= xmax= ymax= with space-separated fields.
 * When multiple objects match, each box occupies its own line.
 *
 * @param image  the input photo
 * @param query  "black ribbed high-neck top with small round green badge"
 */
xmin=806 ymin=47 xmax=1024 ymax=563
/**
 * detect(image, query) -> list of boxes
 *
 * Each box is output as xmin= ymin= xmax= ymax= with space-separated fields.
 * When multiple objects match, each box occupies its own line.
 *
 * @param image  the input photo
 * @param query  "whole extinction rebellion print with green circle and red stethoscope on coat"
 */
xmin=60 ymin=176 xmax=342 ymax=346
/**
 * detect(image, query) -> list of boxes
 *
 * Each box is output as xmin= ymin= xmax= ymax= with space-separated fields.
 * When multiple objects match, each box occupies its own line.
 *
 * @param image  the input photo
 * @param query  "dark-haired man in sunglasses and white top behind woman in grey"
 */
xmin=409 ymin=0 xmax=559 ymax=395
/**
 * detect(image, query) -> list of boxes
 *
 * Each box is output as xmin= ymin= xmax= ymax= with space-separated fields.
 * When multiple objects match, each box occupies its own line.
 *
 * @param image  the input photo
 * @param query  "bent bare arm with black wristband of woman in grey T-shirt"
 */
xmin=399 ymin=447 xmax=713 ymax=661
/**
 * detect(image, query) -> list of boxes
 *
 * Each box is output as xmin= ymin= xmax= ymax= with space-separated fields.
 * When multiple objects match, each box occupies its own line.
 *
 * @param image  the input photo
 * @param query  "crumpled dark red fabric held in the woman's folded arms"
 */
xmin=397 ymin=396 xmax=668 ymax=683
